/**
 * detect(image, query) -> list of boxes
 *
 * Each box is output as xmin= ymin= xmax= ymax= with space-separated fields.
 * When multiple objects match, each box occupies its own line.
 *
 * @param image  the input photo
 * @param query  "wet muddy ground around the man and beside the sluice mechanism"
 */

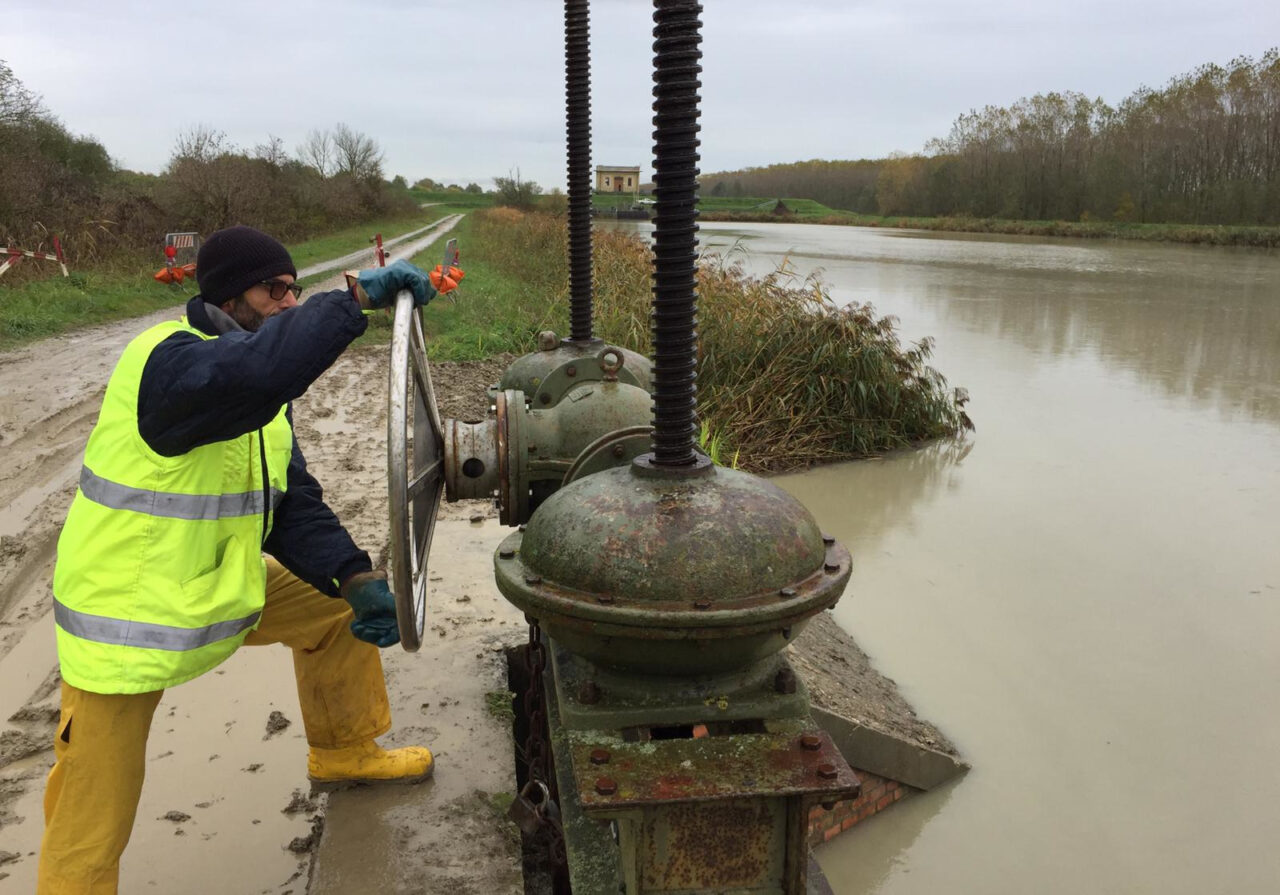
xmin=0 ymin=241 xmax=951 ymax=895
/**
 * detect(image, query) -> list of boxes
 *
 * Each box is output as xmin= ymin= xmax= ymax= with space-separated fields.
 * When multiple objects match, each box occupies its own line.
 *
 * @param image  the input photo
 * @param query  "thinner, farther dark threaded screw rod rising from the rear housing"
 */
xmin=564 ymin=0 xmax=593 ymax=342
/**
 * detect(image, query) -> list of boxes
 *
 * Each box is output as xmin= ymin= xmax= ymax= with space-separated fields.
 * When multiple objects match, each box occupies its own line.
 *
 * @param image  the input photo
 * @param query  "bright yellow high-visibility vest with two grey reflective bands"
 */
xmin=54 ymin=318 xmax=293 ymax=693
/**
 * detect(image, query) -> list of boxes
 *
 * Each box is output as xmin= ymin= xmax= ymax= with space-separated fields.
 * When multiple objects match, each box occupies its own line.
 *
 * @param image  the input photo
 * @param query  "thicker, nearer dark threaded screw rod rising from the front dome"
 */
xmin=653 ymin=0 xmax=703 ymax=466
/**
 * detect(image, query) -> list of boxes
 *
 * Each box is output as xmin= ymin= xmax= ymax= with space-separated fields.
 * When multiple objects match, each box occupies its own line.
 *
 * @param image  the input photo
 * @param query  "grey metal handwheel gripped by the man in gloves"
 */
xmin=387 ymin=289 xmax=444 ymax=652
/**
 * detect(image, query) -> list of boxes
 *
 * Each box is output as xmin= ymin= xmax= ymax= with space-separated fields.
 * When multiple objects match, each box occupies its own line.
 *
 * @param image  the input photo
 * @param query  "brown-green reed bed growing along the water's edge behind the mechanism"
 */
xmin=471 ymin=209 xmax=973 ymax=471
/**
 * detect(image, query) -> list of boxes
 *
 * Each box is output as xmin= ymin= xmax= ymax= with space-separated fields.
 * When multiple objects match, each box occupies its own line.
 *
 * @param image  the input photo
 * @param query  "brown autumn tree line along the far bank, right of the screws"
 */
xmin=703 ymin=49 xmax=1280 ymax=225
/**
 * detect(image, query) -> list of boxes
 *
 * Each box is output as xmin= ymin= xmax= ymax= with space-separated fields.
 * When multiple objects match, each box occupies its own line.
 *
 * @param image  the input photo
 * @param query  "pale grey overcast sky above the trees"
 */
xmin=0 ymin=0 xmax=1280 ymax=188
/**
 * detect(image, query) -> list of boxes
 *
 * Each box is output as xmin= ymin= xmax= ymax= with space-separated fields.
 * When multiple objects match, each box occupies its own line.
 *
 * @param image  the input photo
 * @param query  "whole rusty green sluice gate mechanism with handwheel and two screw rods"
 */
xmin=378 ymin=0 xmax=859 ymax=895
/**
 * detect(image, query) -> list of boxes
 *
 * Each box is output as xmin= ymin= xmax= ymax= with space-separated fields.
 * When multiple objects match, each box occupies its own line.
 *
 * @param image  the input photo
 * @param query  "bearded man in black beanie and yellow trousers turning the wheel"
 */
xmin=37 ymin=227 xmax=435 ymax=895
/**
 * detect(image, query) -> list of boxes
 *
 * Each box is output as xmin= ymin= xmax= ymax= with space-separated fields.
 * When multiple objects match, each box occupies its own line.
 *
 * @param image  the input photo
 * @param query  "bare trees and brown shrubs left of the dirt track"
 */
xmin=0 ymin=60 xmax=416 ymax=264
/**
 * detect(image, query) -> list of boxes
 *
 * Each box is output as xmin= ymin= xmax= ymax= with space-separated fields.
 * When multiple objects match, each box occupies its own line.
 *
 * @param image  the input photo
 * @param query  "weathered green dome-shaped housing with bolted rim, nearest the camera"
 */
xmin=494 ymin=455 xmax=851 ymax=675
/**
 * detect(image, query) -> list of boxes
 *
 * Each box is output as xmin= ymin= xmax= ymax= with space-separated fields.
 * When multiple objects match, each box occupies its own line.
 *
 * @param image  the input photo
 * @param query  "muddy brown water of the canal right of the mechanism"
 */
xmin=609 ymin=218 xmax=1280 ymax=895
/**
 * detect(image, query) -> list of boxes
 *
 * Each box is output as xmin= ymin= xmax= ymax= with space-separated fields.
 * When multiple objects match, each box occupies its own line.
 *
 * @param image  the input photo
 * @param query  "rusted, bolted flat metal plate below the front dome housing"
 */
xmin=568 ymin=723 xmax=859 ymax=812
